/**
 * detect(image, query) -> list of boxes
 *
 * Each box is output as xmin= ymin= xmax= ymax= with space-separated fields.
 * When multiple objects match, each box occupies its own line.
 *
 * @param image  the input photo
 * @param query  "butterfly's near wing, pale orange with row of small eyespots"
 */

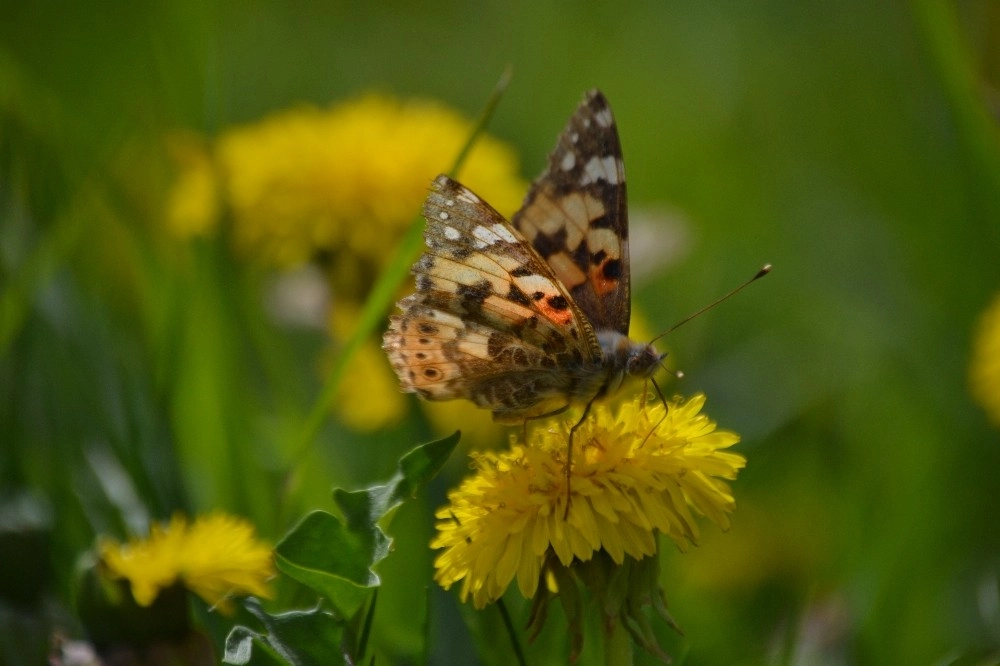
xmin=383 ymin=176 xmax=601 ymax=422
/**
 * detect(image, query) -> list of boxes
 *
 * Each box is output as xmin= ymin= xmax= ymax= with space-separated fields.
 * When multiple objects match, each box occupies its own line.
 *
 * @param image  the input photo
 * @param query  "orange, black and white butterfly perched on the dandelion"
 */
xmin=383 ymin=90 xmax=666 ymax=436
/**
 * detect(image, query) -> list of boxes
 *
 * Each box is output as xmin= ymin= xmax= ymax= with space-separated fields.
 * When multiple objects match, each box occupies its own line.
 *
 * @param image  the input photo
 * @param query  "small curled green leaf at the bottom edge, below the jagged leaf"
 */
xmin=222 ymin=598 xmax=348 ymax=666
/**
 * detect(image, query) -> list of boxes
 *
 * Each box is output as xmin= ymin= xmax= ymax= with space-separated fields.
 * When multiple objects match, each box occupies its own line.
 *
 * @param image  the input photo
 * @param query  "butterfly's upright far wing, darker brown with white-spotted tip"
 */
xmin=511 ymin=90 xmax=631 ymax=335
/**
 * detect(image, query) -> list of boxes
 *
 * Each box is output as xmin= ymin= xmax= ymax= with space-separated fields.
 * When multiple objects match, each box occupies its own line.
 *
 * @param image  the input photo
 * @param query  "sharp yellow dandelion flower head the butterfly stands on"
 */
xmin=431 ymin=394 xmax=745 ymax=608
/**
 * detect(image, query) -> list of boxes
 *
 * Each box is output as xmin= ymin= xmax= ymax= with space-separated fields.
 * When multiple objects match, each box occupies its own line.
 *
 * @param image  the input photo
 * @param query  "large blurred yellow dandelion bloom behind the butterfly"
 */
xmin=210 ymin=94 xmax=525 ymax=274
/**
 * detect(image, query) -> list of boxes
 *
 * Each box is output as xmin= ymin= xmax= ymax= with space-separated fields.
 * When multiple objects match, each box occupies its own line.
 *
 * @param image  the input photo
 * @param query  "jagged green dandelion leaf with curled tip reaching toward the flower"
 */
xmin=275 ymin=432 xmax=460 ymax=617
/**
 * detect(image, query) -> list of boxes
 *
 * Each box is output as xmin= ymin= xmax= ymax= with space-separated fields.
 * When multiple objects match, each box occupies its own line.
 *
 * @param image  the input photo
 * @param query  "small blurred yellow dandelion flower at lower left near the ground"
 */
xmin=98 ymin=512 xmax=275 ymax=612
